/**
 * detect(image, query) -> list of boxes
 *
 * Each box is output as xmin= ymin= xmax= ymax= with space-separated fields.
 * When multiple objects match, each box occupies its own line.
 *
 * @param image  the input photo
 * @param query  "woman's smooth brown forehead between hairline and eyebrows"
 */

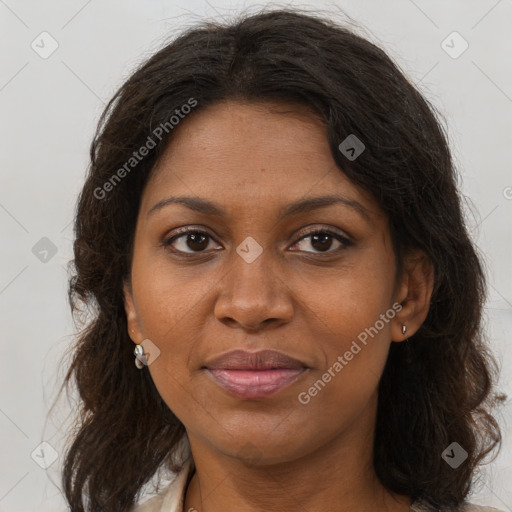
xmin=141 ymin=101 xmax=379 ymax=219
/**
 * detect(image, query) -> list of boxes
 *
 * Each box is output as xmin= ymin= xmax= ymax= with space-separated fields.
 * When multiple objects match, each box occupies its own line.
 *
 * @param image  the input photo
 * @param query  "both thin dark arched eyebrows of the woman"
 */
xmin=147 ymin=195 xmax=371 ymax=222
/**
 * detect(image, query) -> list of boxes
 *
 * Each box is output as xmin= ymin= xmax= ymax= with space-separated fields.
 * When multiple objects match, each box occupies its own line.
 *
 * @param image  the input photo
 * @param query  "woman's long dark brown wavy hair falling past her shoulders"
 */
xmin=62 ymin=9 xmax=501 ymax=512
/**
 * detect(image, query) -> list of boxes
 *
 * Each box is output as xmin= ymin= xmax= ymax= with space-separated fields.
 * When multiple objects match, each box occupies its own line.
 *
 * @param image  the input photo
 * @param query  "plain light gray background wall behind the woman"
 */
xmin=0 ymin=0 xmax=512 ymax=512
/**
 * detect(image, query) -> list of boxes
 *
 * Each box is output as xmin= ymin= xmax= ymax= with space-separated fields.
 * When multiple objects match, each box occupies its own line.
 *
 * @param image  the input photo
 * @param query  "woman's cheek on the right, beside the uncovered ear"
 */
xmin=299 ymin=258 xmax=395 ymax=408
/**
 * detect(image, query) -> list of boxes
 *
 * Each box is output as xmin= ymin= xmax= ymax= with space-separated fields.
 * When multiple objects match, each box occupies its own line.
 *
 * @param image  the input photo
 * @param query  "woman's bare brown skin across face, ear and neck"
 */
xmin=124 ymin=102 xmax=433 ymax=512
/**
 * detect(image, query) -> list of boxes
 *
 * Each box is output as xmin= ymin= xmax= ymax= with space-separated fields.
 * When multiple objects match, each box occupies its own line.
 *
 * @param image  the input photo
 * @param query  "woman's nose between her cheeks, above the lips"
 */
xmin=214 ymin=250 xmax=293 ymax=332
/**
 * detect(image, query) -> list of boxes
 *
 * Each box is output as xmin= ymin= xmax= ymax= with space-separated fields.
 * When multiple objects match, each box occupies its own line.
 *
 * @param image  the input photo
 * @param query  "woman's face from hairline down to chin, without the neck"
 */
xmin=125 ymin=102 xmax=428 ymax=462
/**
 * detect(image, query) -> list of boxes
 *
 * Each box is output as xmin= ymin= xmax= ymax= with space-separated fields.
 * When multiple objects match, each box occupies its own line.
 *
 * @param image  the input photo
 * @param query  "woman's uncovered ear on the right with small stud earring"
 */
xmin=391 ymin=249 xmax=434 ymax=342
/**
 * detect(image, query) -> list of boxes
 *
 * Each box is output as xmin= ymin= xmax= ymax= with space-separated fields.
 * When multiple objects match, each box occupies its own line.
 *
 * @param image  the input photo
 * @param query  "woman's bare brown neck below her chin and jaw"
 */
xmin=184 ymin=400 xmax=411 ymax=512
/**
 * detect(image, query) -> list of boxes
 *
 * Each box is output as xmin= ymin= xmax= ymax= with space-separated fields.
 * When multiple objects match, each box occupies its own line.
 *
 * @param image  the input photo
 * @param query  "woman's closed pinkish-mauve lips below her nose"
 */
xmin=203 ymin=350 xmax=308 ymax=399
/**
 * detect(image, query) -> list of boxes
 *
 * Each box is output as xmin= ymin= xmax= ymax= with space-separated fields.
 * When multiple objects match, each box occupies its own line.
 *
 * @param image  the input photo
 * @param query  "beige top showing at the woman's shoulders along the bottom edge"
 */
xmin=133 ymin=456 xmax=503 ymax=512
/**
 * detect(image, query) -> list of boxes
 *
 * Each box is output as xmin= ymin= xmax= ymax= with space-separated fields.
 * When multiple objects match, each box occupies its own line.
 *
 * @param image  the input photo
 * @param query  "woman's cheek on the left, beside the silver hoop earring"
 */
xmin=132 ymin=249 xmax=220 ymax=410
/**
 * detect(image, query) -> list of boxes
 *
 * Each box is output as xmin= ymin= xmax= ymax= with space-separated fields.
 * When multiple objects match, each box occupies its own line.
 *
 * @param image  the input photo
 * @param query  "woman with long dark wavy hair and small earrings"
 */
xmin=63 ymin=10 xmax=501 ymax=512
